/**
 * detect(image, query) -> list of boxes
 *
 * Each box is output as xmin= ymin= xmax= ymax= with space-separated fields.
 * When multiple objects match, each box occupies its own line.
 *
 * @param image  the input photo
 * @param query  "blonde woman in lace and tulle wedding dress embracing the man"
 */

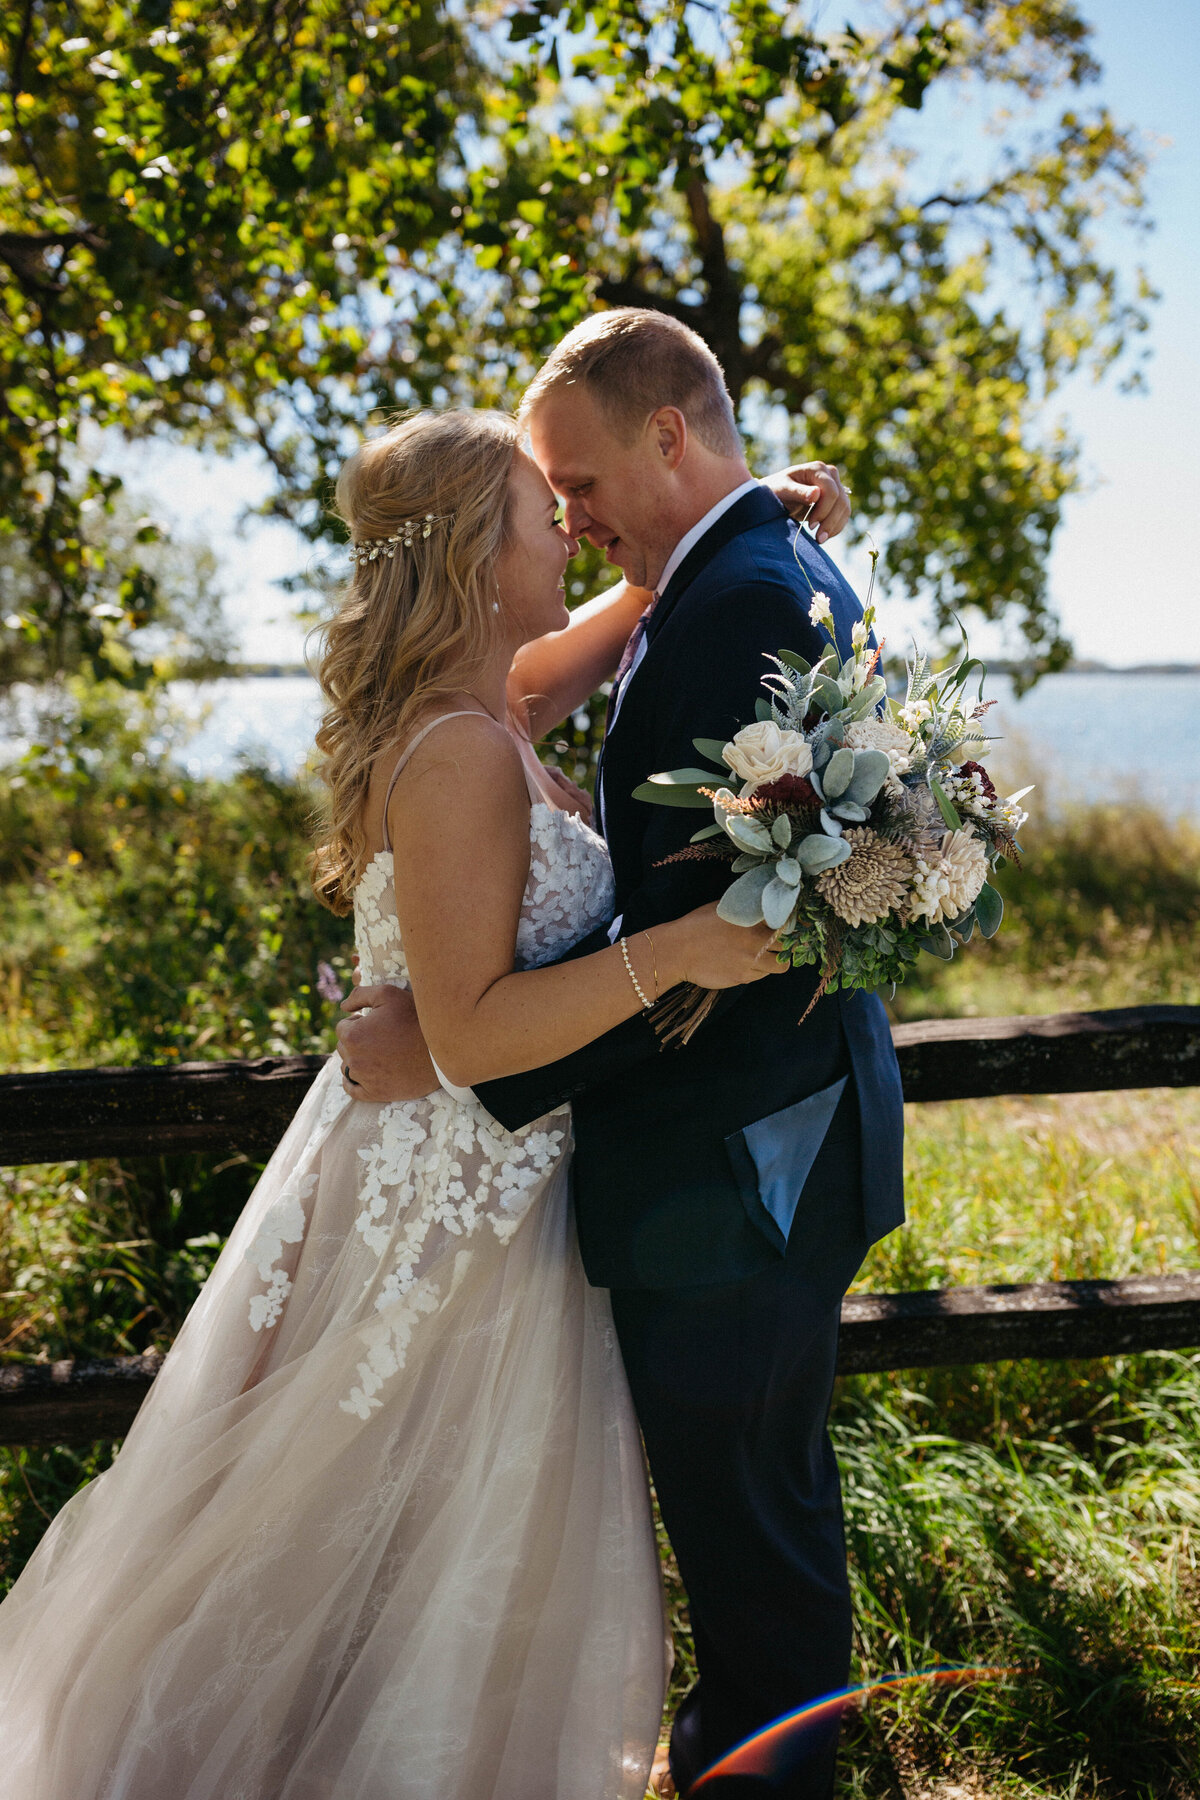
xmin=0 ymin=412 xmax=777 ymax=1800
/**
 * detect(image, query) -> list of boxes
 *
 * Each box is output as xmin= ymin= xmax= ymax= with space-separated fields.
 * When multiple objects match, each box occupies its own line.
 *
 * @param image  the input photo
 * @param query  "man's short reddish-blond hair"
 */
xmin=518 ymin=306 xmax=743 ymax=457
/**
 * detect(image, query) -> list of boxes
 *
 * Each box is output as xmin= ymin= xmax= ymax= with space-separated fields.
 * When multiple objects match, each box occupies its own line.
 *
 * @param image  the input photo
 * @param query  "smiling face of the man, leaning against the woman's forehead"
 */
xmin=529 ymin=387 xmax=682 ymax=589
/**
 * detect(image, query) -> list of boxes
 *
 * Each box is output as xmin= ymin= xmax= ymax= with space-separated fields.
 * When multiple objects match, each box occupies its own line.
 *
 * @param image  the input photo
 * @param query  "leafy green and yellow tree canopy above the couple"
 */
xmin=0 ymin=0 xmax=1144 ymax=687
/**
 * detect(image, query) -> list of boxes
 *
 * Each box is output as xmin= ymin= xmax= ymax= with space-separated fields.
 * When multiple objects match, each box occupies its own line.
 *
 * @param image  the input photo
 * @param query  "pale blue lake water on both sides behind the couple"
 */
xmin=170 ymin=673 xmax=1200 ymax=817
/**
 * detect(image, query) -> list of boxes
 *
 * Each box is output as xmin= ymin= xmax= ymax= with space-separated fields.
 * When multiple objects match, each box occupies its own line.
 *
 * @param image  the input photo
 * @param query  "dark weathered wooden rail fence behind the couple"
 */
xmin=0 ymin=1006 xmax=1200 ymax=1444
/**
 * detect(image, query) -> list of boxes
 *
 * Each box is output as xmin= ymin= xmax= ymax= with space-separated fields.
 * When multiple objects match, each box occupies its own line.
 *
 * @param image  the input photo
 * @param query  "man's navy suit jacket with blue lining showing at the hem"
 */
xmin=475 ymin=488 xmax=903 ymax=1289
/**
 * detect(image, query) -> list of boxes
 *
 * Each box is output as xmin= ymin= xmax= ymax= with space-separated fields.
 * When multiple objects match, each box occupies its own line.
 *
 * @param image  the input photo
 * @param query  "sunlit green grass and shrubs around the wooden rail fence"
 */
xmin=0 ymin=743 xmax=1200 ymax=1800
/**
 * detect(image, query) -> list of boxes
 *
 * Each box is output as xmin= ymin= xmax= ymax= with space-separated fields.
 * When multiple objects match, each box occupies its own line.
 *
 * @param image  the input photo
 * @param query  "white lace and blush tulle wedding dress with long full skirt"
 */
xmin=0 ymin=723 xmax=666 ymax=1800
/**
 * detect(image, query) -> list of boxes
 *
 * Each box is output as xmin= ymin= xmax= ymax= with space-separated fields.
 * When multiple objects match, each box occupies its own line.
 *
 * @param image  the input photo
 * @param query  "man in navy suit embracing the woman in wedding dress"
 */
xmin=344 ymin=310 xmax=903 ymax=1800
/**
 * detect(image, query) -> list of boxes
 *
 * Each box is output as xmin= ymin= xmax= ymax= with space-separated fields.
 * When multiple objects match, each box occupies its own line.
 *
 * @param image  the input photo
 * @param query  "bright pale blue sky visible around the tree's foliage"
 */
xmin=106 ymin=0 xmax=1200 ymax=664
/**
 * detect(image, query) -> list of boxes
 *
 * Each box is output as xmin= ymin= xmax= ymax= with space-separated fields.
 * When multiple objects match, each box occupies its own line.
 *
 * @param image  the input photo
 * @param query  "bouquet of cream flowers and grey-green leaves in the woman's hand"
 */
xmin=633 ymin=594 xmax=1029 ymax=994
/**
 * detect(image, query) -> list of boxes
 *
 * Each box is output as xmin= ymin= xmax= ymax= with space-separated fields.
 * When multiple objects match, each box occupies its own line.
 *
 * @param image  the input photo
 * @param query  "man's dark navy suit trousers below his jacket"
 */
xmin=612 ymin=1084 xmax=867 ymax=1800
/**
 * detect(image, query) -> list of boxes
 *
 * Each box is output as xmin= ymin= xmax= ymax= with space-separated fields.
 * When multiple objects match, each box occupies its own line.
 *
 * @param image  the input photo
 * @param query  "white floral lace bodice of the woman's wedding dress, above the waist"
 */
xmin=354 ymin=799 xmax=613 ymax=988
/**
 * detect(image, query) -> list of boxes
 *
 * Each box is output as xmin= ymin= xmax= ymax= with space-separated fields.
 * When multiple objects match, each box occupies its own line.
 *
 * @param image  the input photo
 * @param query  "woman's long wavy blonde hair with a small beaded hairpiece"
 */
xmin=309 ymin=410 xmax=520 ymax=913
